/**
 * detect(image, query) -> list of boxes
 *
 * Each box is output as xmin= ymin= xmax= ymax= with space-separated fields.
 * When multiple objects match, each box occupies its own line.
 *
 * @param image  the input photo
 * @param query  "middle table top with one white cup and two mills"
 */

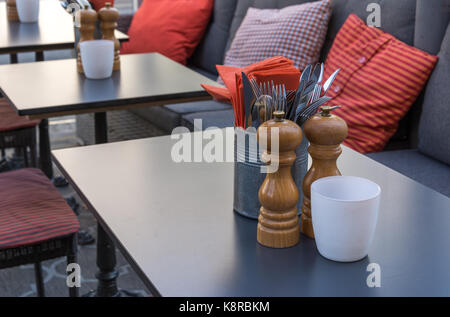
xmin=0 ymin=53 xmax=217 ymax=115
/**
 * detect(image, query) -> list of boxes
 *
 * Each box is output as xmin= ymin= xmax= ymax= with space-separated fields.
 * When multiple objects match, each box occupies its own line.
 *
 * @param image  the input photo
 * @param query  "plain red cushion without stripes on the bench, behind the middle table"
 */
xmin=121 ymin=0 xmax=213 ymax=64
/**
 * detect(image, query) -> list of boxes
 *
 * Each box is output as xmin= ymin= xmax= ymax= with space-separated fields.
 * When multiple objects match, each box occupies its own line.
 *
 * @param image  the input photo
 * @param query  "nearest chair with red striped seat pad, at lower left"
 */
xmin=0 ymin=168 xmax=80 ymax=296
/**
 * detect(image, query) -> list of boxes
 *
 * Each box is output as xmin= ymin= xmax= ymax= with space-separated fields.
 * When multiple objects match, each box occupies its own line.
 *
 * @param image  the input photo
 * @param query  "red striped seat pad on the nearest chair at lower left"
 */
xmin=0 ymin=169 xmax=80 ymax=249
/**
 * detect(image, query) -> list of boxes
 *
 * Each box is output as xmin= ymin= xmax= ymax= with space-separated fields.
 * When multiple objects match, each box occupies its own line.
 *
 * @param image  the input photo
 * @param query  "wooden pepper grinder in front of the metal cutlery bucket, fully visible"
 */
xmin=257 ymin=111 xmax=302 ymax=248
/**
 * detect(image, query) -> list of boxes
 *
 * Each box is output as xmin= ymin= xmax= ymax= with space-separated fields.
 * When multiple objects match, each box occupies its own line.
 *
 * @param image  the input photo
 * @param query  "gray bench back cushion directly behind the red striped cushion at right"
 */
xmin=321 ymin=0 xmax=416 ymax=60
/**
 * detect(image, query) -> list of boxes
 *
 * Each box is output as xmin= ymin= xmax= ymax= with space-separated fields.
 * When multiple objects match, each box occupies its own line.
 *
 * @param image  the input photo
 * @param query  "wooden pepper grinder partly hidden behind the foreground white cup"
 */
xmin=301 ymin=106 xmax=348 ymax=238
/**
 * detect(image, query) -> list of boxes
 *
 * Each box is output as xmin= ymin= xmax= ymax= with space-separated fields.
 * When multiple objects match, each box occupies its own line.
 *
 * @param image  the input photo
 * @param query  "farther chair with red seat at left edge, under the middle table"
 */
xmin=0 ymin=98 xmax=40 ymax=167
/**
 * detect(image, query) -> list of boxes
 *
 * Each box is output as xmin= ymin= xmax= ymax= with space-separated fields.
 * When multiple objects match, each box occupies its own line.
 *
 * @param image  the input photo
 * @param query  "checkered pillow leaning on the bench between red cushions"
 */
xmin=224 ymin=0 xmax=331 ymax=70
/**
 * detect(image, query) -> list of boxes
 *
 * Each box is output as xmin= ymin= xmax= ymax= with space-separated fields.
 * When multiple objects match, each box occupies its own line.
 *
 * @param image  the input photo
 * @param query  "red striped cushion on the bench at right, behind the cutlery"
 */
xmin=324 ymin=14 xmax=437 ymax=153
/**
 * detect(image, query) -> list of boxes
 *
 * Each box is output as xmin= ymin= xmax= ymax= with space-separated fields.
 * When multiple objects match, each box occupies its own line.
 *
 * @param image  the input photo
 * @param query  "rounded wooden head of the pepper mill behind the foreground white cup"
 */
xmin=304 ymin=106 xmax=348 ymax=145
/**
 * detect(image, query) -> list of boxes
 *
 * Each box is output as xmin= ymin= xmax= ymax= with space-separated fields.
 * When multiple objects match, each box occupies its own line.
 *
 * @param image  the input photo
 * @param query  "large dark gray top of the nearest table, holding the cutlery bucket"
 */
xmin=53 ymin=131 xmax=450 ymax=296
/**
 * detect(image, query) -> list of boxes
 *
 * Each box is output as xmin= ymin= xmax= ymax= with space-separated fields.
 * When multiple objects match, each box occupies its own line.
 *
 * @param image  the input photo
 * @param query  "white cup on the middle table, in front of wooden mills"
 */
xmin=80 ymin=40 xmax=114 ymax=79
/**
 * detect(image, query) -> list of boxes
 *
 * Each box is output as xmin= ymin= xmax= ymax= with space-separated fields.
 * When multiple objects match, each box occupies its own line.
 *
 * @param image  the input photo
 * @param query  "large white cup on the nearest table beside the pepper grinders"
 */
xmin=311 ymin=176 xmax=381 ymax=262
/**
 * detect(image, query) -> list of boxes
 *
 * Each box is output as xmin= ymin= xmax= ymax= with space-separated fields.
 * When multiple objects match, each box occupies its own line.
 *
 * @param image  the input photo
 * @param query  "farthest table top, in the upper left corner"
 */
xmin=0 ymin=0 xmax=128 ymax=54
